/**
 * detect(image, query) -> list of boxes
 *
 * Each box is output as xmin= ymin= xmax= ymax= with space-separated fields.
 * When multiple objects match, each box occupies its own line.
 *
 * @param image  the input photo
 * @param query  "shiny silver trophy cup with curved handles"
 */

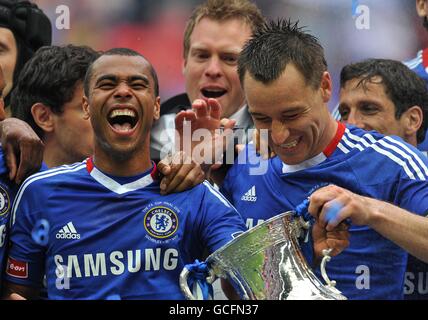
xmin=180 ymin=211 xmax=346 ymax=300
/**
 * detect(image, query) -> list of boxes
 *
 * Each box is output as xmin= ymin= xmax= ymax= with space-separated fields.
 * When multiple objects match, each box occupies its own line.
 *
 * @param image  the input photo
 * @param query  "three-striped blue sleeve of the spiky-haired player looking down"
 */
xmin=348 ymin=137 xmax=428 ymax=215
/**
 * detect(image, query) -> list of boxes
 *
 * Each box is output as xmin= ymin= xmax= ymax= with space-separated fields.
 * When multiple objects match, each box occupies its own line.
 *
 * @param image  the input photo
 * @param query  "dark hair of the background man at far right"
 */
xmin=340 ymin=59 xmax=428 ymax=143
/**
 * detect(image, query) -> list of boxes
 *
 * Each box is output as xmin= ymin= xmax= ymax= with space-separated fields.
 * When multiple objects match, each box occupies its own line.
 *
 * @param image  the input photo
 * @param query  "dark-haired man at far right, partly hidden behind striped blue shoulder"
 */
xmin=339 ymin=59 xmax=428 ymax=300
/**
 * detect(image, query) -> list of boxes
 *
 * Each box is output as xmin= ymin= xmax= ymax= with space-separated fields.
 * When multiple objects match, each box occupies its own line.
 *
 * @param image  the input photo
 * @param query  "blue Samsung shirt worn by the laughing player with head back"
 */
xmin=6 ymin=159 xmax=245 ymax=299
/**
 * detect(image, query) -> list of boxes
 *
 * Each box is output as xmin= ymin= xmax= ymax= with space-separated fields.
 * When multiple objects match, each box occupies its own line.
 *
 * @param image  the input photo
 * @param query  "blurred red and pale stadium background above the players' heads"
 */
xmin=33 ymin=0 xmax=428 ymax=108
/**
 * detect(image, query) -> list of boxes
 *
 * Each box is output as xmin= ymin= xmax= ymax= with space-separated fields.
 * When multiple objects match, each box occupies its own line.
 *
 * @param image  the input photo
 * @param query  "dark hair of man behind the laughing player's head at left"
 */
xmin=11 ymin=45 xmax=99 ymax=138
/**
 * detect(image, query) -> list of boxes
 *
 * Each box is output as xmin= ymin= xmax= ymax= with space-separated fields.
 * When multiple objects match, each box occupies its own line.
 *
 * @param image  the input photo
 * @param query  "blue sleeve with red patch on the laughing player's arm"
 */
xmin=5 ymin=184 xmax=45 ymax=288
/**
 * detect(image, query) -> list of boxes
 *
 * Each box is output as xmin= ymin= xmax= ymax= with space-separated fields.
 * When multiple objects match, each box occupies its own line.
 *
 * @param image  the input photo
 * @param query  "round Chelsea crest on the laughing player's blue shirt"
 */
xmin=144 ymin=206 xmax=178 ymax=239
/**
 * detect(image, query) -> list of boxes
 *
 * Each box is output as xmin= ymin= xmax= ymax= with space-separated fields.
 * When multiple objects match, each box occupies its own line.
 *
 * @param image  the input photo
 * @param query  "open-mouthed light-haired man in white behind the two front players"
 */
xmin=150 ymin=0 xmax=265 ymax=164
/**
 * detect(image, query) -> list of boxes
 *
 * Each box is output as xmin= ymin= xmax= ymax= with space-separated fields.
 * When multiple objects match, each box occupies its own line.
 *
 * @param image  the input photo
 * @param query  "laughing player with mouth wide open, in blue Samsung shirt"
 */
xmin=2 ymin=49 xmax=245 ymax=299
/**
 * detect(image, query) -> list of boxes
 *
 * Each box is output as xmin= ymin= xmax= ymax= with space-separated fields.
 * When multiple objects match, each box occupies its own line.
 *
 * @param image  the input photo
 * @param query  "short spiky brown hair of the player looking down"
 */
xmin=238 ymin=19 xmax=327 ymax=88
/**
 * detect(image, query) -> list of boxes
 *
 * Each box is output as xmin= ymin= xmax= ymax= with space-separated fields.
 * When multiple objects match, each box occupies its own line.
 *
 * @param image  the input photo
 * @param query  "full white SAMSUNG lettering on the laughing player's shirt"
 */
xmin=54 ymin=248 xmax=178 ymax=278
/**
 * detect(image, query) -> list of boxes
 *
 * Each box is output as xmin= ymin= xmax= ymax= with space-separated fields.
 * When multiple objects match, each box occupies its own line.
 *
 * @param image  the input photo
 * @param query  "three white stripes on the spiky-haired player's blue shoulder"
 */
xmin=342 ymin=128 xmax=428 ymax=181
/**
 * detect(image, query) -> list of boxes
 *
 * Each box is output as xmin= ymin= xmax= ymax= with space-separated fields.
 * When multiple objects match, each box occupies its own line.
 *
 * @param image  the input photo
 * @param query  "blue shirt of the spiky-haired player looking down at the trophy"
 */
xmin=221 ymin=123 xmax=428 ymax=299
